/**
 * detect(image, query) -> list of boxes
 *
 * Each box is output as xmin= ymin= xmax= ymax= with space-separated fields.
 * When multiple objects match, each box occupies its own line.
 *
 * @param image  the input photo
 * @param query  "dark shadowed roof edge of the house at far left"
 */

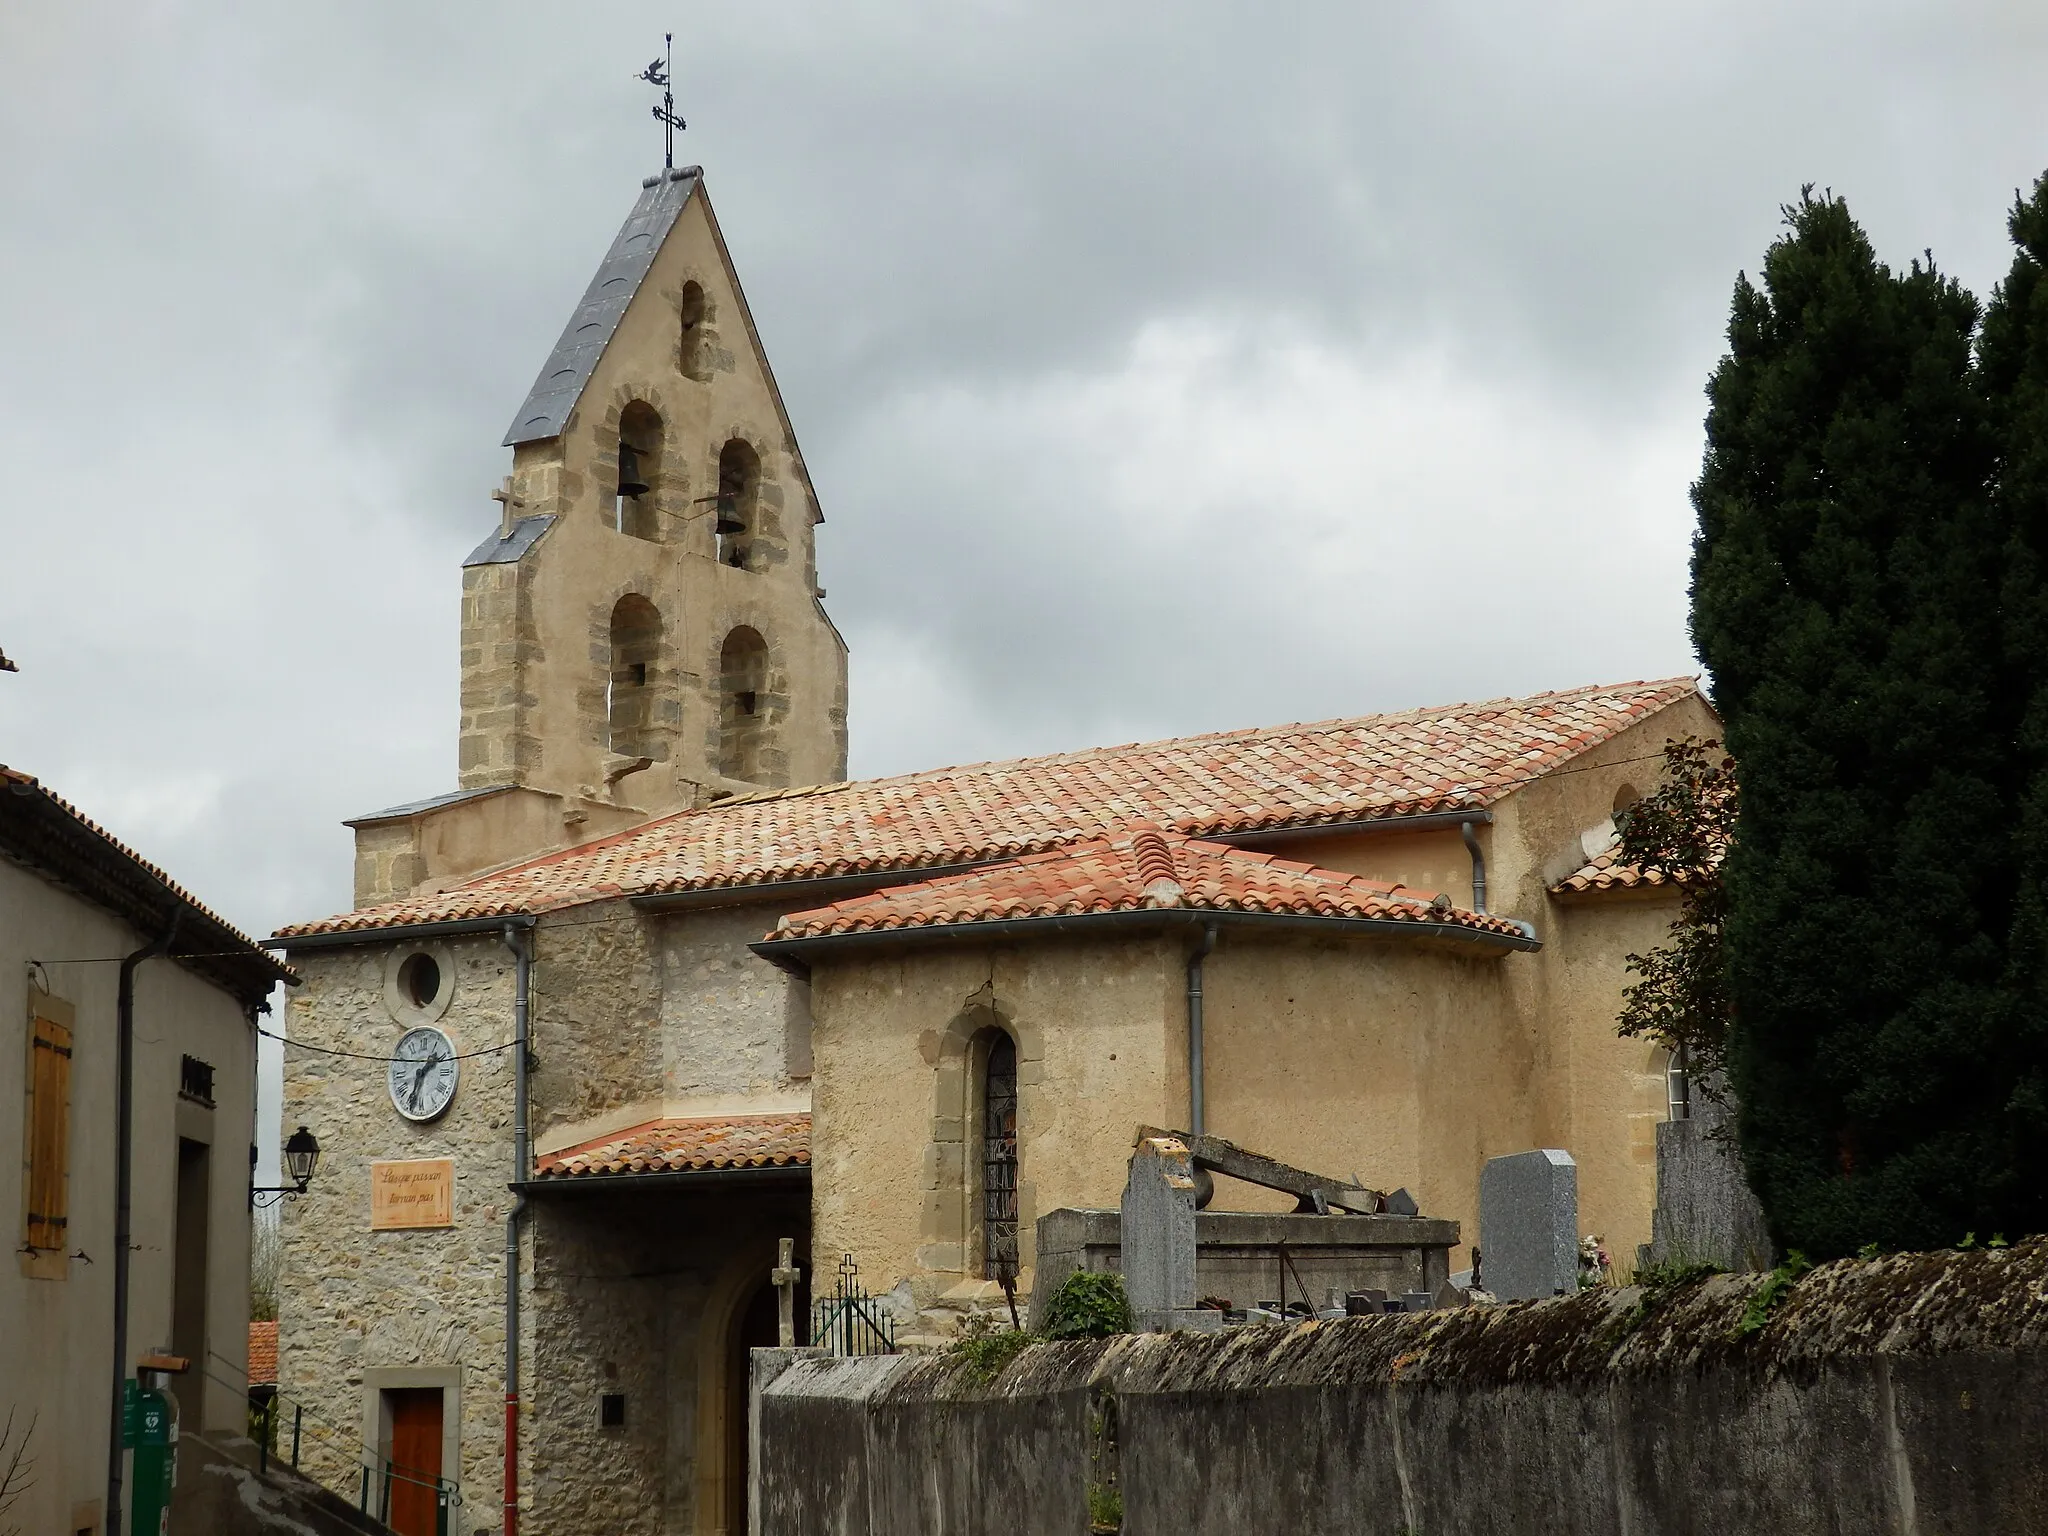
xmin=0 ymin=764 xmax=297 ymax=1001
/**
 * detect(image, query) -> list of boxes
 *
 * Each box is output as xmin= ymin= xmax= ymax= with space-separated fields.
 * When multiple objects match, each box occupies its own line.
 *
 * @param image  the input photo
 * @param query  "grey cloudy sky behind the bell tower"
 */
xmin=0 ymin=0 xmax=2048 ymax=950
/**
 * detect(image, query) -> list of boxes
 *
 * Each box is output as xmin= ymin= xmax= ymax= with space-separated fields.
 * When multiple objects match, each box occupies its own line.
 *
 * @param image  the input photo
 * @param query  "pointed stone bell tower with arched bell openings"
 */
xmin=350 ymin=166 xmax=846 ymax=905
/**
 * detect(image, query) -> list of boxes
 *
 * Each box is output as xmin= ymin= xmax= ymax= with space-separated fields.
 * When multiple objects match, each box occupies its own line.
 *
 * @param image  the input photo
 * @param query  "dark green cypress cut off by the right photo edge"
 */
xmin=1978 ymin=176 xmax=2048 ymax=1233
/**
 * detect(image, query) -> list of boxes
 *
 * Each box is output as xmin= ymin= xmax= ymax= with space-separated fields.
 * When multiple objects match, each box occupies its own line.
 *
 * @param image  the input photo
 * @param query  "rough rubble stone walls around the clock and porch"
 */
xmin=279 ymin=903 xmax=809 ymax=1532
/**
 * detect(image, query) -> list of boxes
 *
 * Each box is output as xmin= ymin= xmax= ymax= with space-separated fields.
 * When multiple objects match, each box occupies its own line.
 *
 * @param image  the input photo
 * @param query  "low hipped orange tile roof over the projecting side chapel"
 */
xmin=770 ymin=823 xmax=1524 ymax=938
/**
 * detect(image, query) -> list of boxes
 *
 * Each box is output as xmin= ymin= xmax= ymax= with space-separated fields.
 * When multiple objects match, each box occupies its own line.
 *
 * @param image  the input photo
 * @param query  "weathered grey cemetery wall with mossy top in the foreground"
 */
xmin=754 ymin=1239 xmax=2048 ymax=1536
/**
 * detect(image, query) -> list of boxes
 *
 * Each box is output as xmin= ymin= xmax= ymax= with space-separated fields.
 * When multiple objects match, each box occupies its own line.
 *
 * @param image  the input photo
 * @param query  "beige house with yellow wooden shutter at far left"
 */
xmin=0 ymin=768 xmax=289 ymax=1536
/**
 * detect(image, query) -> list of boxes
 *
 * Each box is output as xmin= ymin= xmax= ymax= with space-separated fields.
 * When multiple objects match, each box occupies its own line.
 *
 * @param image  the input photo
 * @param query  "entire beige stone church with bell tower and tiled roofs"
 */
xmin=272 ymin=168 xmax=1718 ymax=1536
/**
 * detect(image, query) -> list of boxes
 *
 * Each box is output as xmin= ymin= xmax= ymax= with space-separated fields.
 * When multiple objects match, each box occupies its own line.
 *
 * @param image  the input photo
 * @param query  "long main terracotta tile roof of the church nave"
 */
xmin=279 ymin=678 xmax=1694 ymax=938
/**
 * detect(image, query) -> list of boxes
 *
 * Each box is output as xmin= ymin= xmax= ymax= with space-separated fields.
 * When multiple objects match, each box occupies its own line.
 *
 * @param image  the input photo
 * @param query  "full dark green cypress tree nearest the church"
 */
xmin=1692 ymin=188 xmax=2017 ymax=1257
